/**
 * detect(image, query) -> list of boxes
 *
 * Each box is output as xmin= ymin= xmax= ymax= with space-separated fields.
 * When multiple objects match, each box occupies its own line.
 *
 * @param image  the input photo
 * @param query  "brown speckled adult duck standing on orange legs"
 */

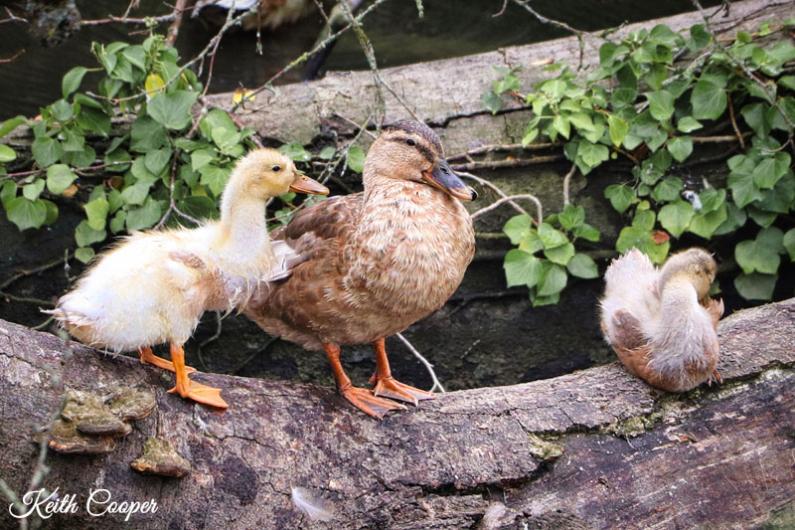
xmin=245 ymin=121 xmax=476 ymax=418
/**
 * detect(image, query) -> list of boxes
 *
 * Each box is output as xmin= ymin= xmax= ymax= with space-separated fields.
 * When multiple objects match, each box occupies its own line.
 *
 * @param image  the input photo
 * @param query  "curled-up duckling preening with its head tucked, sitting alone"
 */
xmin=601 ymin=248 xmax=723 ymax=392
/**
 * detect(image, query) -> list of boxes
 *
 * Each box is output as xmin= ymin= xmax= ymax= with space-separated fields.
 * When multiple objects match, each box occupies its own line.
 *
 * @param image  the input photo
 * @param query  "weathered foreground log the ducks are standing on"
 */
xmin=0 ymin=298 xmax=795 ymax=529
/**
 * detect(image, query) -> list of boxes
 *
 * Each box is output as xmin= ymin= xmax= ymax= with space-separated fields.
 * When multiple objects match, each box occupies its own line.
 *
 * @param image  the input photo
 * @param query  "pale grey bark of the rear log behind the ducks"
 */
xmin=207 ymin=0 xmax=795 ymax=154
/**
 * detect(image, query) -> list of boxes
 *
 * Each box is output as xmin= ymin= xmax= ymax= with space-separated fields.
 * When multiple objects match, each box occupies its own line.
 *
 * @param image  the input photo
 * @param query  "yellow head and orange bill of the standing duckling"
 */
xmin=230 ymin=148 xmax=328 ymax=199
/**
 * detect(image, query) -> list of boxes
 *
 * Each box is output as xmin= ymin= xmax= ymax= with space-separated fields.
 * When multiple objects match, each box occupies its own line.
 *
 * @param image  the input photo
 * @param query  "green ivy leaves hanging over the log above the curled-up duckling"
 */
xmin=483 ymin=19 xmax=795 ymax=305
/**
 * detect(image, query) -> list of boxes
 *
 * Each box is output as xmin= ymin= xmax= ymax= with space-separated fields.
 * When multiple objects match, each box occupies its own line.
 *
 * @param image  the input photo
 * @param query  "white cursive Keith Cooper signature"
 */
xmin=8 ymin=488 xmax=158 ymax=521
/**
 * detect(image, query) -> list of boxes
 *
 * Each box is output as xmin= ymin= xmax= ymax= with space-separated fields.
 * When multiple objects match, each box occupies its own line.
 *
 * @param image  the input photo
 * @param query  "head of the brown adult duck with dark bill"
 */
xmin=365 ymin=120 xmax=477 ymax=201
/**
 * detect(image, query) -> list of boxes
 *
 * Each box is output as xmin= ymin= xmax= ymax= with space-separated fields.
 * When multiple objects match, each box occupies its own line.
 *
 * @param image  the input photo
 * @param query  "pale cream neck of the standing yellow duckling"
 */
xmin=216 ymin=181 xmax=273 ymax=269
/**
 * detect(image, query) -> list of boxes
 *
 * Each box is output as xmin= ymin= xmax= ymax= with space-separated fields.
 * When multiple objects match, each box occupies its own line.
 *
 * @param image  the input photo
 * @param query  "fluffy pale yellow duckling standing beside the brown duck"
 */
xmin=51 ymin=149 xmax=328 ymax=408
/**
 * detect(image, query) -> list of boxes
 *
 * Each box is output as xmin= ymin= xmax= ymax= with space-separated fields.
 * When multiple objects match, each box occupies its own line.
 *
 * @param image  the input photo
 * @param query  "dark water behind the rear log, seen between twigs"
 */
xmin=0 ymin=0 xmax=720 ymax=119
